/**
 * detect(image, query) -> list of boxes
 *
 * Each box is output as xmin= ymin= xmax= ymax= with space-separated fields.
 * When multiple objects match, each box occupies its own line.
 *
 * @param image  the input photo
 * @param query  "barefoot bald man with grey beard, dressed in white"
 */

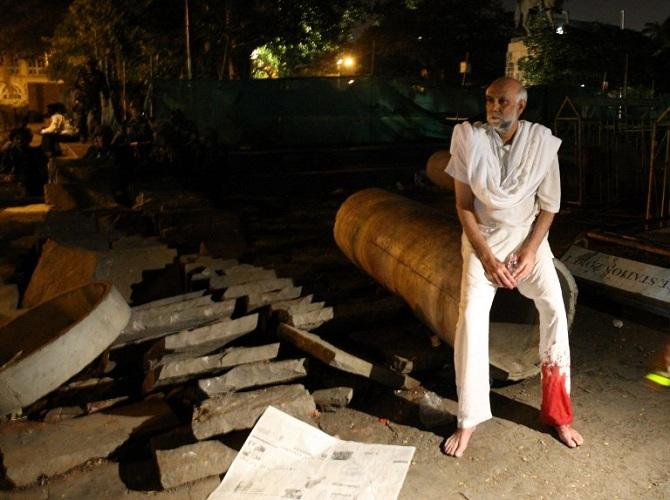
xmin=443 ymin=78 xmax=584 ymax=457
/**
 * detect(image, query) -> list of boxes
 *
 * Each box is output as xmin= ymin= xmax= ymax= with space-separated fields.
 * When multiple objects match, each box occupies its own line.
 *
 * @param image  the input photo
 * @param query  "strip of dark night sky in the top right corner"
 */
xmin=503 ymin=0 xmax=670 ymax=30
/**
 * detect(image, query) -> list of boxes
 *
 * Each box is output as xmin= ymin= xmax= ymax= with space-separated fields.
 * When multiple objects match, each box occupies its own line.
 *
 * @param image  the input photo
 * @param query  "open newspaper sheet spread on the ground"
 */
xmin=209 ymin=406 xmax=415 ymax=500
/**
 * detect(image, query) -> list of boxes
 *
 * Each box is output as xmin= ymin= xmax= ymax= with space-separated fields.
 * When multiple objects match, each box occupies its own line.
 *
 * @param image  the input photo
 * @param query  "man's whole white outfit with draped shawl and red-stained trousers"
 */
xmin=446 ymin=121 xmax=572 ymax=428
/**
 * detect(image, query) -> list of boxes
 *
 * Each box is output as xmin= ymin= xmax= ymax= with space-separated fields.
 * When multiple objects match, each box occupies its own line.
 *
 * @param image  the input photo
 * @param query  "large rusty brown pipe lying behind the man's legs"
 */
xmin=334 ymin=189 xmax=577 ymax=380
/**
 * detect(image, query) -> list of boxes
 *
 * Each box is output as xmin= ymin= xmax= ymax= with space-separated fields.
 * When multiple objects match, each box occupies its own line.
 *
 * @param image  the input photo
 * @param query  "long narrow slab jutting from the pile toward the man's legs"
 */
xmin=277 ymin=323 xmax=421 ymax=389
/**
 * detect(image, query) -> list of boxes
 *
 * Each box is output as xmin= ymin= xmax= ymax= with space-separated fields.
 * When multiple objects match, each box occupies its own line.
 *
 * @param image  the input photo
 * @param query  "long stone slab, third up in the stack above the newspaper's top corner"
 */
xmin=143 ymin=342 xmax=279 ymax=392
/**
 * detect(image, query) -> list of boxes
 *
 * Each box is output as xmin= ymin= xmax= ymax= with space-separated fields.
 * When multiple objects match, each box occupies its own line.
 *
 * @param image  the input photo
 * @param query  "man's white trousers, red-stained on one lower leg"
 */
xmin=454 ymin=226 xmax=572 ymax=428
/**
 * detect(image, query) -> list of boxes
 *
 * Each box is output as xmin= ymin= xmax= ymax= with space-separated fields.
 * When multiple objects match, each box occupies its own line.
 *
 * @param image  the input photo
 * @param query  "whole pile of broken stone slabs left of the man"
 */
xmin=0 ymin=240 xmax=426 ymax=491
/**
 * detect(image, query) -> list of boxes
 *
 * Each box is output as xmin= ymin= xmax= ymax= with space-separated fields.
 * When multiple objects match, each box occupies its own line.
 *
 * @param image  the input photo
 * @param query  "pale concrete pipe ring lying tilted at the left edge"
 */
xmin=0 ymin=281 xmax=130 ymax=415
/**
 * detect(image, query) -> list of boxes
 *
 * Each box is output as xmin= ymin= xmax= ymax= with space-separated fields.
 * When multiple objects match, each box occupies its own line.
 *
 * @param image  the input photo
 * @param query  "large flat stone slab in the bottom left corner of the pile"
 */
xmin=0 ymin=399 xmax=178 ymax=486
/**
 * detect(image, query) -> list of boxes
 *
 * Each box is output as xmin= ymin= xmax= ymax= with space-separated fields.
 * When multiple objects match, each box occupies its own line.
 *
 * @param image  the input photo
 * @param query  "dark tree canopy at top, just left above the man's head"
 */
xmin=357 ymin=0 xmax=513 ymax=84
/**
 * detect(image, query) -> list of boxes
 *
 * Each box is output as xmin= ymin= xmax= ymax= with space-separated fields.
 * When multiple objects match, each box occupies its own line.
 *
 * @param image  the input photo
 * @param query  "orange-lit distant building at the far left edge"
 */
xmin=0 ymin=54 xmax=63 ymax=112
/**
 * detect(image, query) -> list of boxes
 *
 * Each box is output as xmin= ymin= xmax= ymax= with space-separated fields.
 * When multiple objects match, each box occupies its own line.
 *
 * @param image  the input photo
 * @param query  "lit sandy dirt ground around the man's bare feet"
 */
xmin=266 ymin=187 xmax=670 ymax=500
